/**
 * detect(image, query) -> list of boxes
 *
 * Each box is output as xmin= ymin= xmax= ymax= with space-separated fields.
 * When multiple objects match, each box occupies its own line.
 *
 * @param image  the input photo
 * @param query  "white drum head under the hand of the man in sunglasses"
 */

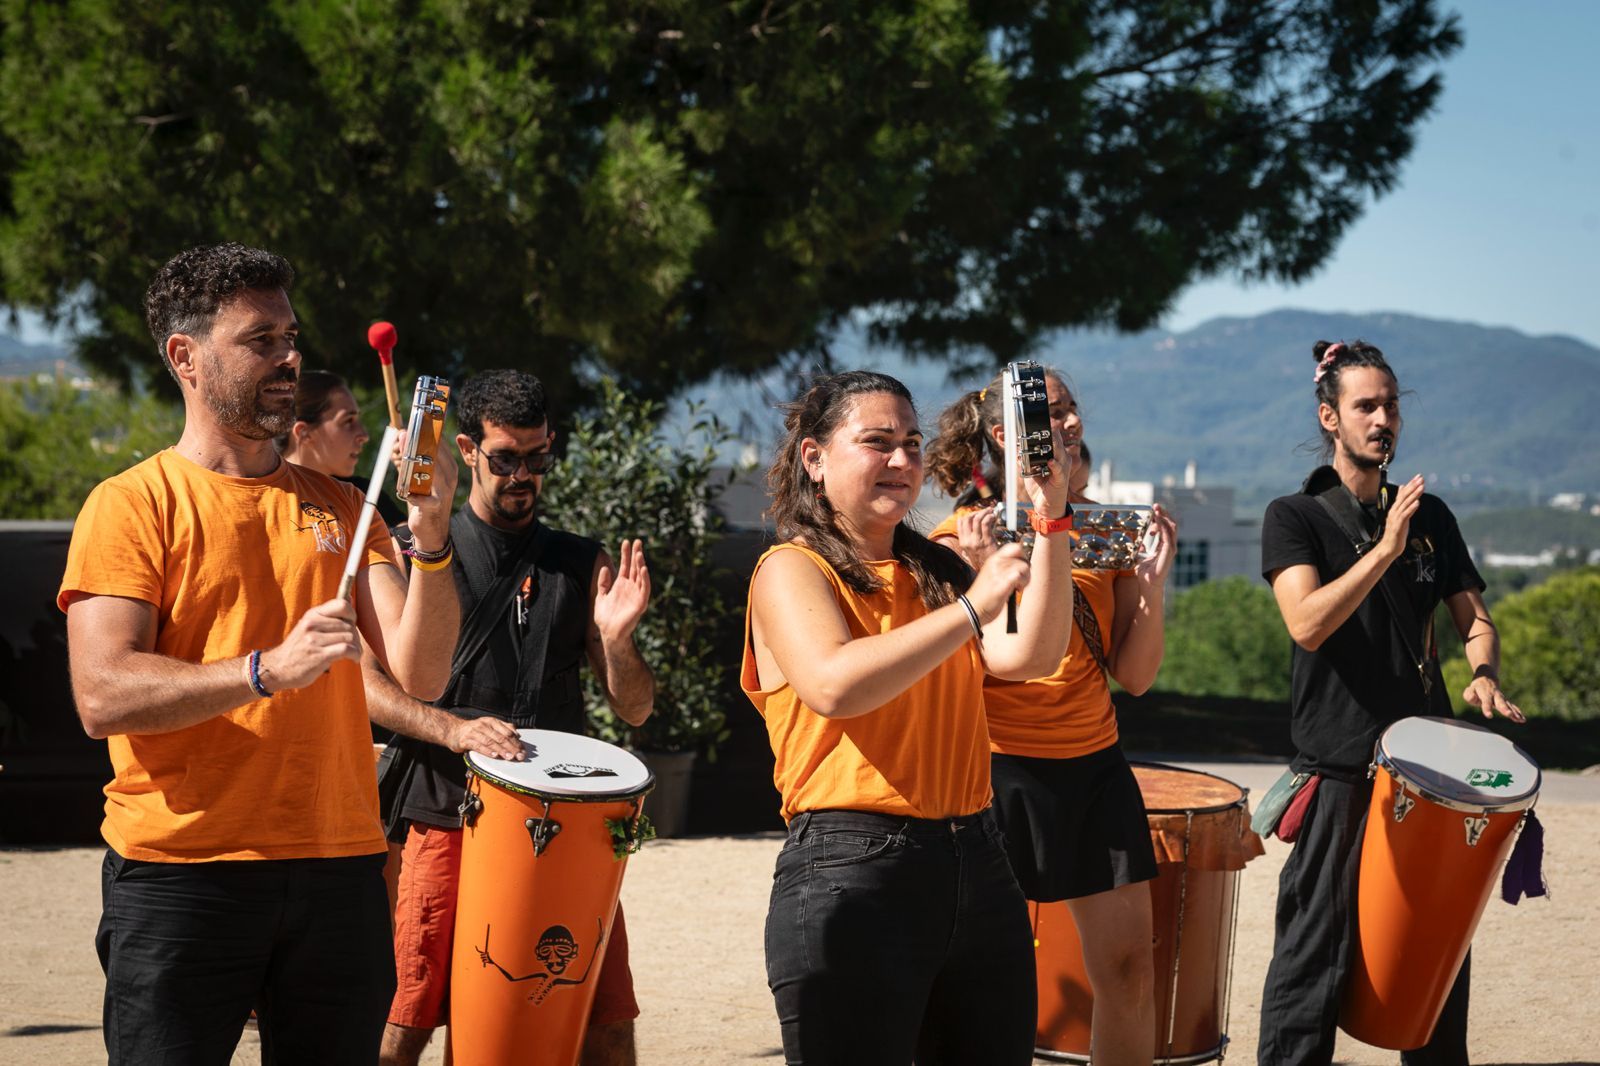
xmin=467 ymin=730 xmax=654 ymax=800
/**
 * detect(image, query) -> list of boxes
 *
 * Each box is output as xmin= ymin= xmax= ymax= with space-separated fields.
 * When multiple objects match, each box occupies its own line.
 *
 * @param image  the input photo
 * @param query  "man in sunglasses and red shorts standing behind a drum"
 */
xmin=373 ymin=370 xmax=656 ymax=1066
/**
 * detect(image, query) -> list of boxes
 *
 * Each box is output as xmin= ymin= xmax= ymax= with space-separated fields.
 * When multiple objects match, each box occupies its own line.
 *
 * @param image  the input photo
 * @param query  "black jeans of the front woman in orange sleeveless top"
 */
xmin=766 ymin=812 xmax=1037 ymax=1066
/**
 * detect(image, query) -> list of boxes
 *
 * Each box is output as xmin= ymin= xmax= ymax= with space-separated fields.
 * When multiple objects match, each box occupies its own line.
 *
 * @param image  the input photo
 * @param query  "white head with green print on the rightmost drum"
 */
xmin=1378 ymin=717 xmax=1541 ymax=810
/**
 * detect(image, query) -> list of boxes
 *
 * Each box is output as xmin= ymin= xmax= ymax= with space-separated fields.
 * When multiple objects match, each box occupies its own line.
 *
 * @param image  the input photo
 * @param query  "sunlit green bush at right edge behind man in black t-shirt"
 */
xmin=1443 ymin=567 xmax=1600 ymax=719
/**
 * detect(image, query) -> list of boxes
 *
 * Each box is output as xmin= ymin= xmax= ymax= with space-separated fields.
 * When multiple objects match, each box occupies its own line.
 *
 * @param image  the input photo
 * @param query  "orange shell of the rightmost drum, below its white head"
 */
xmin=1339 ymin=765 xmax=1523 ymax=1050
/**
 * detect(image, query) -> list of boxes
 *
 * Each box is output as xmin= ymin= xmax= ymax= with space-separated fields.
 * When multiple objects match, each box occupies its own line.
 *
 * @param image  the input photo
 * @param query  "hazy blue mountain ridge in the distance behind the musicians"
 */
xmin=675 ymin=311 xmax=1600 ymax=509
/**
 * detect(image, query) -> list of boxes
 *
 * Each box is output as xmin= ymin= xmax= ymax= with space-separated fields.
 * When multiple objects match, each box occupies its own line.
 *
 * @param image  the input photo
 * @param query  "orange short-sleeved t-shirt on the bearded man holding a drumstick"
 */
xmin=56 ymin=448 xmax=394 ymax=863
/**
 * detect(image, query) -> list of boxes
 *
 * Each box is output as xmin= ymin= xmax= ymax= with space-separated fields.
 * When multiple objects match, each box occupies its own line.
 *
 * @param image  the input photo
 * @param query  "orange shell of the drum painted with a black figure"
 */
xmin=450 ymin=776 xmax=642 ymax=1066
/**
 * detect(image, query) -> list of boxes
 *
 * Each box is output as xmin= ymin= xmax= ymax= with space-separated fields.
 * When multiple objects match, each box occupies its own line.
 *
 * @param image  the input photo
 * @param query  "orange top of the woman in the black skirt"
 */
xmin=930 ymin=512 xmax=1131 ymax=759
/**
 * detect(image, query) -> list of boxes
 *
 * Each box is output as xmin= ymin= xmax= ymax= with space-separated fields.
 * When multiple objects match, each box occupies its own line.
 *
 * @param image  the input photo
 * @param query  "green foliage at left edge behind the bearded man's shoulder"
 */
xmin=0 ymin=381 xmax=182 ymax=519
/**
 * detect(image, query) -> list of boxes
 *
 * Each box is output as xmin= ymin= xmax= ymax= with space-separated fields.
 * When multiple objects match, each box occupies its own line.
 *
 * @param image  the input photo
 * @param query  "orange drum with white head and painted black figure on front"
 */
xmin=450 ymin=730 xmax=654 ymax=1066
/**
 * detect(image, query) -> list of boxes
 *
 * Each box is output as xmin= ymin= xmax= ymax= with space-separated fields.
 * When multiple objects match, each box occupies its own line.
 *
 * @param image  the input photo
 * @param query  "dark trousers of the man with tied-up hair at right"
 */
xmin=1256 ymin=778 xmax=1472 ymax=1066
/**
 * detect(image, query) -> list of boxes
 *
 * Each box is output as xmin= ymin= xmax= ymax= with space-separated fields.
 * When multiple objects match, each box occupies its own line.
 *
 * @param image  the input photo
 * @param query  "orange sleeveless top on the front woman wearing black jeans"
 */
xmin=739 ymin=544 xmax=990 ymax=821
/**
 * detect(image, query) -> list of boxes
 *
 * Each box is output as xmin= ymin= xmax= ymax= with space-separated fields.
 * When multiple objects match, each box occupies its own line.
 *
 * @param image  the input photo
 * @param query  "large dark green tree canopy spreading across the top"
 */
xmin=0 ymin=0 xmax=1461 ymax=407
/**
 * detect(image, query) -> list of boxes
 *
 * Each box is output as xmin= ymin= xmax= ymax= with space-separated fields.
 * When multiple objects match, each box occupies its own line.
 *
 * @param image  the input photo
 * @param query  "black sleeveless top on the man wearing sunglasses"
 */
xmin=379 ymin=507 xmax=600 ymax=840
